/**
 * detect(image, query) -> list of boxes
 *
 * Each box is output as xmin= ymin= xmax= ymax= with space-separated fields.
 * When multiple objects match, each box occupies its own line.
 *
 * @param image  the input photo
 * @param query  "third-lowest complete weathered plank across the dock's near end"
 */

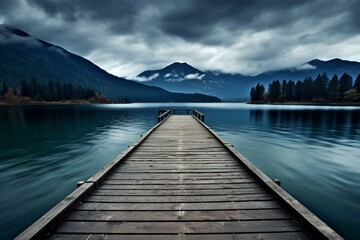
xmin=76 ymin=201 xmax=281 ymax=211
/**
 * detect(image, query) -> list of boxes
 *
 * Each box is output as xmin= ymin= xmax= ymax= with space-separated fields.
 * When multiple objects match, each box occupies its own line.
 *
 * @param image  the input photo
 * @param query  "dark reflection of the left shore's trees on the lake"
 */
xmin=0 ymin=106 xmax=146 ymax=153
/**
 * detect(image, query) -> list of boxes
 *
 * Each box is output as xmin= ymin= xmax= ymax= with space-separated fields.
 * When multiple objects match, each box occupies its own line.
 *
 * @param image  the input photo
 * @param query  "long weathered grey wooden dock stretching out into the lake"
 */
xmin=17 ymin=111 xmax=342 ymax=240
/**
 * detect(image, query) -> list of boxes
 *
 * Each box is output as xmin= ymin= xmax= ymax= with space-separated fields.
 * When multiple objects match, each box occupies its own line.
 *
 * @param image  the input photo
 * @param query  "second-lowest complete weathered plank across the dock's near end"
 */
xmin=66 ymin=209 xmax=292 ymax=222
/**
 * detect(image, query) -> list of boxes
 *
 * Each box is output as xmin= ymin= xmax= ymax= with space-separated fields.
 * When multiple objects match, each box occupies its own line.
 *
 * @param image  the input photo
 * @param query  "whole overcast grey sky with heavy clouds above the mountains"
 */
xmin=0 ymin=0 xmax=360 ymax=78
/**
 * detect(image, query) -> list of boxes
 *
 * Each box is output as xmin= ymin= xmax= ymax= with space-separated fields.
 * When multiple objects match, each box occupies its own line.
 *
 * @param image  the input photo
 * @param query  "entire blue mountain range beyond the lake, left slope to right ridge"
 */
xmin=0 ymin=24 xmax=360 ymax=101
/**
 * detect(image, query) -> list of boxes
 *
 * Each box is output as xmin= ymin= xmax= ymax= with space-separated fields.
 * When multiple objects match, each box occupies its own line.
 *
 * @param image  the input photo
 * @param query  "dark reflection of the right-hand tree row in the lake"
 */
xmin=250 ymin=110 xmax=360 ymax=138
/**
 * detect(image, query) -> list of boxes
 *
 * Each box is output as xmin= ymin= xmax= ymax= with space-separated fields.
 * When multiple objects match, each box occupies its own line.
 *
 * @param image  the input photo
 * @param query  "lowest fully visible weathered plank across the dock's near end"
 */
xmin=56 ymin=220 xmax=302 ymax=234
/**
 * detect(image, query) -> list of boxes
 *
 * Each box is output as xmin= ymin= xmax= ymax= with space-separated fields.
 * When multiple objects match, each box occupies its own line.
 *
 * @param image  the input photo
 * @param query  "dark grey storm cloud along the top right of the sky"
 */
xmin=159 ymin=0 xmax=360 ymax=42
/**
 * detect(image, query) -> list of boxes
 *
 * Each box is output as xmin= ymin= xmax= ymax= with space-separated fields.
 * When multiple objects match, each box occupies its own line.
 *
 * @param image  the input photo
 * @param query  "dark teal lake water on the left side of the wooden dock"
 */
xmin=0 ymin=106 xmax=157 ymax=239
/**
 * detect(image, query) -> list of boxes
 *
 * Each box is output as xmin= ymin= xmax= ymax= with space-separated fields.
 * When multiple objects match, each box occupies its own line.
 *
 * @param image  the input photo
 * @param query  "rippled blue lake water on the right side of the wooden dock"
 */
xmin=204 ymin=106 xmax=360 ymax=239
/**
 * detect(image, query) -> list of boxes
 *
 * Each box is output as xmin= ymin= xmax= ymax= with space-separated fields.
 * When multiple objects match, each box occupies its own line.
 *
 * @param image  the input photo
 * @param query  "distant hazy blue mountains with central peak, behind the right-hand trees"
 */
xmin=136 ymin=59 xmax=360 ymax=100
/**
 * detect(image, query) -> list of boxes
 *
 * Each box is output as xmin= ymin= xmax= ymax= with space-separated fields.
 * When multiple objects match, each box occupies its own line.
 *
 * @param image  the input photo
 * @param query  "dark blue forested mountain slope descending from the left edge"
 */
xmin=0 ymin=25 xmax=219 ymax=102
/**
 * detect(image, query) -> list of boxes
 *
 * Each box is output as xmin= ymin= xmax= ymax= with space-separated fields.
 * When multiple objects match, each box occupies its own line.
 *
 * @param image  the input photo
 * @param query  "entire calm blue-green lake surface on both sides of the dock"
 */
xmin=0 ymin=103 xmax=360 ymax=239
